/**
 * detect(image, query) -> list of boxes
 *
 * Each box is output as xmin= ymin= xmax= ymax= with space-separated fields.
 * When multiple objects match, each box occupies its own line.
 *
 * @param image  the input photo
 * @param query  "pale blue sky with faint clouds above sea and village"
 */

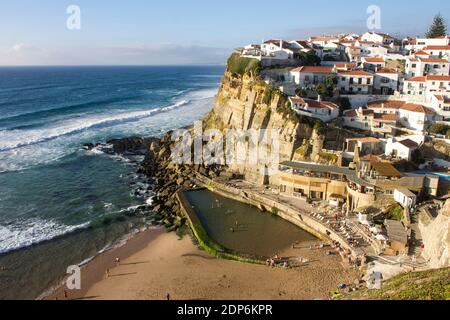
xmin=0 ymin=0 xmax=450 ymax=65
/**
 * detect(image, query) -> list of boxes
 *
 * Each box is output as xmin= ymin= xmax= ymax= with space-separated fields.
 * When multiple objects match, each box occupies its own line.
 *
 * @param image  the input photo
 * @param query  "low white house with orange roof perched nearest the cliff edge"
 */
xmin=289 ymin=97 xmax=339 ymax=122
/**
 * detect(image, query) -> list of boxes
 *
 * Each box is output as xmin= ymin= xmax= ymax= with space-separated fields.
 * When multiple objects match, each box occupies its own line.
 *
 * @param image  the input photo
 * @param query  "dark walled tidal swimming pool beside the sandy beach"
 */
xmin=185 ymin=190 xmax=317 ymax=257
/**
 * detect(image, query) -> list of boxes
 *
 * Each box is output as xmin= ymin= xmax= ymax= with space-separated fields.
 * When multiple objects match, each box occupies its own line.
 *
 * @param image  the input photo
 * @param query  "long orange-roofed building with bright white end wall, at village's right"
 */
xmin=367 ymin=100 xmax=442 ymax=133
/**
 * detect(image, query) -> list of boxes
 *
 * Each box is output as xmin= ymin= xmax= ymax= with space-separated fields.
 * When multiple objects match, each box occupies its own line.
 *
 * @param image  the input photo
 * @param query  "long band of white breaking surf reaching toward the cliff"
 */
xmin=0 ymin=89 xmax=217 ymax=173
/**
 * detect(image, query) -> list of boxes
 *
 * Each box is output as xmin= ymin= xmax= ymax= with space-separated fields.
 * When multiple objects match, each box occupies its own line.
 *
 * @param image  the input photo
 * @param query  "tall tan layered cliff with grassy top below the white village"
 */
xmin=204 ymin=55 xmax=354 ymax=182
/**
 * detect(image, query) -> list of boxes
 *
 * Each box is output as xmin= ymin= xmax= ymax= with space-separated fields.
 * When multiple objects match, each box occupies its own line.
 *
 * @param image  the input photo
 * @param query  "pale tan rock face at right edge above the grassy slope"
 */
xmin=419 ymin=200 xmax=450 ymax=268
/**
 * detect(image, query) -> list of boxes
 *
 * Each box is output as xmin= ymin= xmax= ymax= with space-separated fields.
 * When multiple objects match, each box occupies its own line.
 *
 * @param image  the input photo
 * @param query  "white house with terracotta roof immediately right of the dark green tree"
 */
xmin=338 ymin=70 xmax=374 ymax=94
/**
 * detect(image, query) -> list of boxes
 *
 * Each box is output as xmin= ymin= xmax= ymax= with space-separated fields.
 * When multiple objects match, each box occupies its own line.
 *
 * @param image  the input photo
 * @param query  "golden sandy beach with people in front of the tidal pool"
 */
xmin=47 ymin=229 xmax=358 ymax=300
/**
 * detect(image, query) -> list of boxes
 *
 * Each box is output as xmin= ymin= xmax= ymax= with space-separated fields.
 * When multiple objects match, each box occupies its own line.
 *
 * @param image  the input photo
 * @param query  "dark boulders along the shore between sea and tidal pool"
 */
xmin=83 ymin=132 xmax=223 ymax=231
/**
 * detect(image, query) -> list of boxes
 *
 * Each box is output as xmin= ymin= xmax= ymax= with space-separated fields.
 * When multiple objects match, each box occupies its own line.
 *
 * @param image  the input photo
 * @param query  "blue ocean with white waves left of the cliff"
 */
xmin=0 ymin=66 xmax=224 ymax=299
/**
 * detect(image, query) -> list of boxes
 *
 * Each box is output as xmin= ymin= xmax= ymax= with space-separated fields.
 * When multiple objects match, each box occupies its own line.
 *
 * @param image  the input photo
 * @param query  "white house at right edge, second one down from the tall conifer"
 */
xmin=405 ymin=57 xmax=450 ymax=78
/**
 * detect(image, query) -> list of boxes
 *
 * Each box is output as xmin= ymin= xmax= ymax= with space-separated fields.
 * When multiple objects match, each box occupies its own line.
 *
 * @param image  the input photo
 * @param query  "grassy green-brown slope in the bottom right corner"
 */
xmin=341 ymin=268 xmax=450 ymax=300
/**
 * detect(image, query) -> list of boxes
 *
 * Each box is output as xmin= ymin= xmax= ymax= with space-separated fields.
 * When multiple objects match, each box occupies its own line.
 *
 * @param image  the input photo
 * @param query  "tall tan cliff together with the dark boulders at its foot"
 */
xmin=107 ymin=54 xmax=356 ymax=229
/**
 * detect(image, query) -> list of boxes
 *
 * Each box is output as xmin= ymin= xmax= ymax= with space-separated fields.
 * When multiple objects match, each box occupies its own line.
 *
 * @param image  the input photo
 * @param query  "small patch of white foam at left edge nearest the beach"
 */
xmin=0 ymin=219 xmax=89 ymax=254
